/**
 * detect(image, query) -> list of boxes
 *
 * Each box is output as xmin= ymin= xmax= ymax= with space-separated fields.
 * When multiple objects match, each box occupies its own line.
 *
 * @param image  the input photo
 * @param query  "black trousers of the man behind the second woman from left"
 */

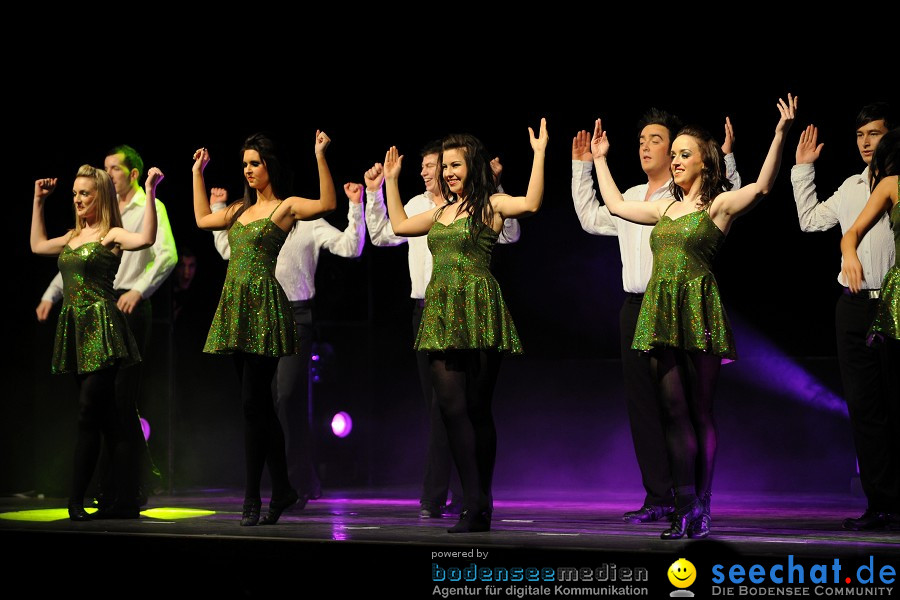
xmin=275 ymin=300 xmax=321 ymax=498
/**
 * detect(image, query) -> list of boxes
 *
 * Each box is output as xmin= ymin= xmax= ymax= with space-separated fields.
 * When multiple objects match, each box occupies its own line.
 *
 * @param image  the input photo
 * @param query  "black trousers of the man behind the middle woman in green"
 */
xmin=412 ymin=300 xmax=462 ymax=508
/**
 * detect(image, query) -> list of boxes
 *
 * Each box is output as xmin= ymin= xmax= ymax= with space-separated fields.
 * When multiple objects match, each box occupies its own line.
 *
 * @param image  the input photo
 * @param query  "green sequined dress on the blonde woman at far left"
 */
xmin=50 ymin=242 xmax=141 ymax=373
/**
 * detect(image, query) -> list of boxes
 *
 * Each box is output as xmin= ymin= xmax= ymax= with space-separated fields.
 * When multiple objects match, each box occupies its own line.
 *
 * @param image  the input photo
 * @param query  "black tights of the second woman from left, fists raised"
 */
xmin=234 ymin=352 xmax=292 ymax=500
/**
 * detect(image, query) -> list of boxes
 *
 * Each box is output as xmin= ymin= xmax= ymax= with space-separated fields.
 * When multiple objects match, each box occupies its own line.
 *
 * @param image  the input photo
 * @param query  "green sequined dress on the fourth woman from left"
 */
xmin=632 ymin=202 xmax=737 ymax=360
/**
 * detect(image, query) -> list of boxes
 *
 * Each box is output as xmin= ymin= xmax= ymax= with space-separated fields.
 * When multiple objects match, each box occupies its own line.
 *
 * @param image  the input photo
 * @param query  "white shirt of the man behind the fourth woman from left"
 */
xmin=572 ymin=154 xmax=741 ymax=294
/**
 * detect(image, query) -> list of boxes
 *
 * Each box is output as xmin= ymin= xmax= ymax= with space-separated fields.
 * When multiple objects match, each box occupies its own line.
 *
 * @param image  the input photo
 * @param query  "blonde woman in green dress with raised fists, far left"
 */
xmin=31 ymin=165 xmax=163 ymax=521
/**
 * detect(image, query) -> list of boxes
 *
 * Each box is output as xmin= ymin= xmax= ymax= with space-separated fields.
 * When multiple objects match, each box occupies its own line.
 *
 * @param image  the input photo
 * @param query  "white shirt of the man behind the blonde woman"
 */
xmin=41 ymin=189 xmax=178 ymax=303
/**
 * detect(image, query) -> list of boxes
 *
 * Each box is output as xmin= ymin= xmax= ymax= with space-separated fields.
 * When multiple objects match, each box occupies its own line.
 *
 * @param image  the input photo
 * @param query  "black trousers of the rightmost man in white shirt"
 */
xmin=835 ymin=293 xmax=900 ymax=512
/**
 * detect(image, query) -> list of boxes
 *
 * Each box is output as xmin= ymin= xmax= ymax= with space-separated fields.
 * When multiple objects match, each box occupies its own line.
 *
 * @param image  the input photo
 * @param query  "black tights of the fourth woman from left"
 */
xmin=651 ymin=348 xmax=722 ymax=507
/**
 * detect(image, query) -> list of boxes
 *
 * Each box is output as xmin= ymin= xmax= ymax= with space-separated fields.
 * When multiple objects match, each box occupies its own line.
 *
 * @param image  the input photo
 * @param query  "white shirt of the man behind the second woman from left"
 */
xmin=212 ymin=202 xmax=366 ymax=302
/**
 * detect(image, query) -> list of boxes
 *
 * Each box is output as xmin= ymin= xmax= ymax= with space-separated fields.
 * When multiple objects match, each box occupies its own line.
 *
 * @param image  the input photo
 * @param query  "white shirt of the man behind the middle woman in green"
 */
xmin=366 ymin=188 xmax=522 ymax=300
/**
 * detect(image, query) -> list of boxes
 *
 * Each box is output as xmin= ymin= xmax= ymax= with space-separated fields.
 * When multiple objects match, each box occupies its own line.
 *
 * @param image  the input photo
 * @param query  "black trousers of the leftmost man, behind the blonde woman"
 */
xmin=98 ymin=290 xmax=159 ymax=505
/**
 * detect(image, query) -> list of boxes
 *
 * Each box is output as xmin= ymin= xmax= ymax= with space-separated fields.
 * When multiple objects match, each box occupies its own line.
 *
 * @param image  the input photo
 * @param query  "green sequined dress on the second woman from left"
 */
xmin=203 ymin=211 xmax=299 ymax=357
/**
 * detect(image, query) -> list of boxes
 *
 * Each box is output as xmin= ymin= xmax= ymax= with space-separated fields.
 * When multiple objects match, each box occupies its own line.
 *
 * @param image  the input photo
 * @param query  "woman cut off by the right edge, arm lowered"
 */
xmin=841 ymin=128 xmax=900 ymax=342
